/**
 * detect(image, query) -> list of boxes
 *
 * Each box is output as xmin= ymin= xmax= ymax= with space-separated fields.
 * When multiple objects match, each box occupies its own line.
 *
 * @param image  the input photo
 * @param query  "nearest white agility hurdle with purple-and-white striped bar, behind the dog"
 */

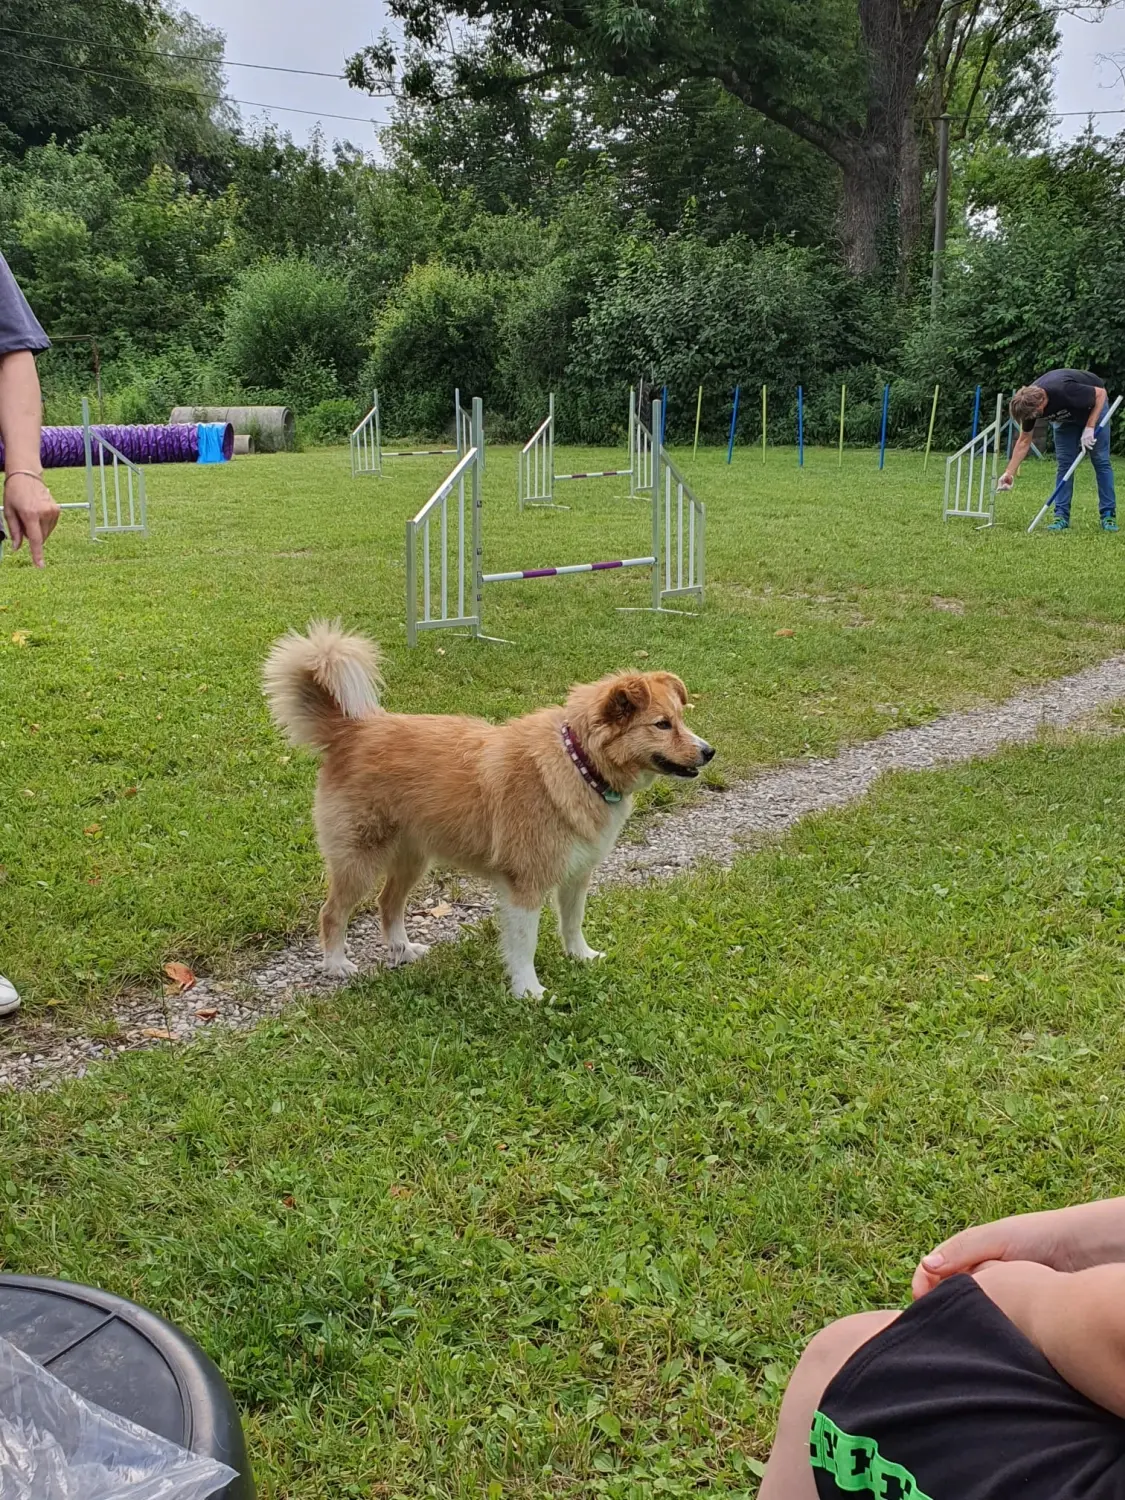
xmin=407 ymin=398 xmax=707 ymax=647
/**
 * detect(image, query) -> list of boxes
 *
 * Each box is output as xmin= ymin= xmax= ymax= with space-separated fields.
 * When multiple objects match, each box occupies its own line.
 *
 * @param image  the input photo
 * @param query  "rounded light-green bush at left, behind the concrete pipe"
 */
xmin=222 ymin=257 xmax=363 ymax=401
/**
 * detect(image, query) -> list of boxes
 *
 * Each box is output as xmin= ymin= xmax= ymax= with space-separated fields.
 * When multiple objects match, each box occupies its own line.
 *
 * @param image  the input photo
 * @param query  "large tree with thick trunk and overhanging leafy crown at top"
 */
xmin=348 ymin=0 xmax=1115 ymax=273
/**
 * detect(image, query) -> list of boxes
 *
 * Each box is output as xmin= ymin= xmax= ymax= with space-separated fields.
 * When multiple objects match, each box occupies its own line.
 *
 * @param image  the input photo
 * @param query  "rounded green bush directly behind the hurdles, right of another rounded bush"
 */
xmin=366 ymin=261 xmax=500 ymax=437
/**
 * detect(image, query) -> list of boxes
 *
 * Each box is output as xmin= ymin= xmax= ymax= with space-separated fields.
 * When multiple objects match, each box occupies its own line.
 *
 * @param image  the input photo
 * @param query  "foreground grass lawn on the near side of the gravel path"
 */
xmin=0 ymin=732 xmax=1125 ymax=1500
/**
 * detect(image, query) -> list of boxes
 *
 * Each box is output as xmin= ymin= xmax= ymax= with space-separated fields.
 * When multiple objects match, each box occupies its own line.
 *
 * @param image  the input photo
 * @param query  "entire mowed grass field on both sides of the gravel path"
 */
xmin=0 ymin=438 xmax=1125 ymax=1500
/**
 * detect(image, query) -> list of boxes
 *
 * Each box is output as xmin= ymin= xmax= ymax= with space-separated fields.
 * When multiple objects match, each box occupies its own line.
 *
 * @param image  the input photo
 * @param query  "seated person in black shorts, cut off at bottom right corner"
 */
xmin=759 ymin=1199 xmax=1125 ymax=1500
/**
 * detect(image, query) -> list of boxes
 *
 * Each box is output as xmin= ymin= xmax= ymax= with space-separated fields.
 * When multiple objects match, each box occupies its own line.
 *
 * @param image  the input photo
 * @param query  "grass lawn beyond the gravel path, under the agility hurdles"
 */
xmin=0 ymin=435 xmax=1125 ymax=1026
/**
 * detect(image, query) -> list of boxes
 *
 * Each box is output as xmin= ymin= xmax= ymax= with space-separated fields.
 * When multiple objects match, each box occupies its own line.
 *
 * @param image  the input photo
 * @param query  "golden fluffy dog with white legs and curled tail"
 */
xmin=264 ymin=623 xmax=714 ymax=996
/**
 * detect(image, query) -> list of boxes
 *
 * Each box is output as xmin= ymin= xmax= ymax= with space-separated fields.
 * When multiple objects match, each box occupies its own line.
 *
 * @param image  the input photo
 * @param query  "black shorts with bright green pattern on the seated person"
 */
xmin=812 ymin=1277 xmax=1125 ymax=1500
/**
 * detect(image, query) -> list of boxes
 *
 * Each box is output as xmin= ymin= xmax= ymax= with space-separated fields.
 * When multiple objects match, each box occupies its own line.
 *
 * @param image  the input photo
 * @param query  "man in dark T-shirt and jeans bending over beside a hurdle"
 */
xmin=996 ymin=371 xmax=1118 ymax=531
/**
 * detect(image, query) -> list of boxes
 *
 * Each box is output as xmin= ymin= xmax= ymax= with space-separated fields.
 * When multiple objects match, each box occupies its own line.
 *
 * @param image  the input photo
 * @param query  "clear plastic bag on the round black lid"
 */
xmin=0 ymin=1338 xmax=236 ymax=1500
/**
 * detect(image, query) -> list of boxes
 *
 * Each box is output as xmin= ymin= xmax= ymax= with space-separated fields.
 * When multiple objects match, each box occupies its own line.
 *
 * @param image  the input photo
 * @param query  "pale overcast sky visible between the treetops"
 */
xmin=185 ymin=0 xmax=1125 ymax=150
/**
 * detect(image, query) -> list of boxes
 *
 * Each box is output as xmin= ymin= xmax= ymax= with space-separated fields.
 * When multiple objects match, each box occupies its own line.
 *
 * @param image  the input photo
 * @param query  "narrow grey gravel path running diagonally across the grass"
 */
xmin=0 ymin=657 xmax=1125 ymax=1089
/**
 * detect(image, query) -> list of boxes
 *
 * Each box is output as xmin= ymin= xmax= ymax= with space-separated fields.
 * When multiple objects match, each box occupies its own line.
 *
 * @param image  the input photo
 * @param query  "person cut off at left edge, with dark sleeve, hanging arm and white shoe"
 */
xmin=0 ymin=255 xmax=59 ymax=1016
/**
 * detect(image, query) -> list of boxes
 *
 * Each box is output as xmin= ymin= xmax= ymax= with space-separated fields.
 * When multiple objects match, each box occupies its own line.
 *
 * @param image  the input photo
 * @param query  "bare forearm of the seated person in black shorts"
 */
xmin=914 ymin=1199 xmax=1125 ymax=1298
